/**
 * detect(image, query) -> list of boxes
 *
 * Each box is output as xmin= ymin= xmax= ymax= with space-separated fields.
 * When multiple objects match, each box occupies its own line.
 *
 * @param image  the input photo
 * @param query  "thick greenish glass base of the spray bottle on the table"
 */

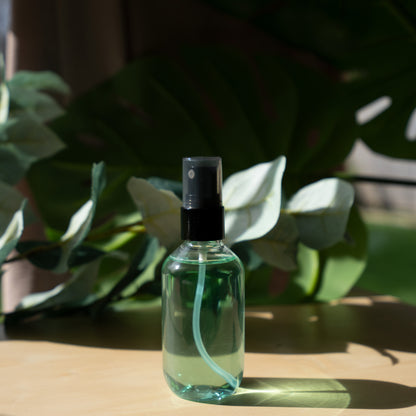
xmin=165 ymin=374 xmax=236 ymax=403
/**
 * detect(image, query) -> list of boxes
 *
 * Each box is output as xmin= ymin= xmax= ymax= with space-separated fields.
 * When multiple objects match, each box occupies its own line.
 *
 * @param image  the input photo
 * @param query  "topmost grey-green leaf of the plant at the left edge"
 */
xmin=8 ymin=71 xmax=70 ymax=95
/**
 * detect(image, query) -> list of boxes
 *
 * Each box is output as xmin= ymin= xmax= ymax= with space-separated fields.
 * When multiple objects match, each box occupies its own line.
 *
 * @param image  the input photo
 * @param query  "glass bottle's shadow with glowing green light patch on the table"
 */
xmin=218 ymin=378 xmax=416 ymax=409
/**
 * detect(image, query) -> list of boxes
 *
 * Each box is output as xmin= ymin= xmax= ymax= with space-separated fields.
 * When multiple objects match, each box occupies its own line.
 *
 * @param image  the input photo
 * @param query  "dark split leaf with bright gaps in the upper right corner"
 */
xmin=205 ymin=0 xmax=416 ymax=161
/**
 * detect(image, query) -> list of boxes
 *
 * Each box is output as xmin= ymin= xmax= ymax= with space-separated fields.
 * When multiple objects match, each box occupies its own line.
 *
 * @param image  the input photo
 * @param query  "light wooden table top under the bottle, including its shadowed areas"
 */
xmin=0 ymin=296 xmax=416 ymax=416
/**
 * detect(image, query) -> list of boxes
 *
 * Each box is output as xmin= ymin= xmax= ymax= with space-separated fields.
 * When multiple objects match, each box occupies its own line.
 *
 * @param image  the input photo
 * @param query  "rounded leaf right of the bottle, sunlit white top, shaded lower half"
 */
xmin=287 ymin=178 xmax=354 ymax=250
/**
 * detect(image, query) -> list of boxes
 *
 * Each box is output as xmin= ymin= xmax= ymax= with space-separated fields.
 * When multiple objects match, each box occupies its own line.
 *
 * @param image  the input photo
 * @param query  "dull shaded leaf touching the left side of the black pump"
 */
xmin=127 ymin=178 xmax=182 ymax=248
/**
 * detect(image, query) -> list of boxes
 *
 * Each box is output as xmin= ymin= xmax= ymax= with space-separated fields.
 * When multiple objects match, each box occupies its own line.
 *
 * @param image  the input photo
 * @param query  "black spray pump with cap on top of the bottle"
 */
xmin=181 ymin=157 xmax=224 ymax=241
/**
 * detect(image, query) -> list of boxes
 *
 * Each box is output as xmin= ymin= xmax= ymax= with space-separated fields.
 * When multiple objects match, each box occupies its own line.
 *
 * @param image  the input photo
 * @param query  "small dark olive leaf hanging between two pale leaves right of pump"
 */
xmin=251 ymin=213 xmax=299 ymax=271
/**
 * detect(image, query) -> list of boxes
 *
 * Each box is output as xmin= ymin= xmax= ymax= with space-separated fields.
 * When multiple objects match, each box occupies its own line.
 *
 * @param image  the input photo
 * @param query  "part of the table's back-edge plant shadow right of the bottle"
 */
xmin=246 ymin=297 xmax=416 ymax=358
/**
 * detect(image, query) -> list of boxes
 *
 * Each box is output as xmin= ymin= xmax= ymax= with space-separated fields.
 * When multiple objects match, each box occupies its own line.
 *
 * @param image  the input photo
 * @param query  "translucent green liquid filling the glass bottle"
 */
xmin=162 ymin=252 xmax=244 ymax=401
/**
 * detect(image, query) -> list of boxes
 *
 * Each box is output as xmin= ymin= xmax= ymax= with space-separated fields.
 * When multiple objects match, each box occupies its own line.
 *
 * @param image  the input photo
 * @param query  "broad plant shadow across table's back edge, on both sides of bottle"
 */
xmin=4 ymin=297 xmax=416 ymax=358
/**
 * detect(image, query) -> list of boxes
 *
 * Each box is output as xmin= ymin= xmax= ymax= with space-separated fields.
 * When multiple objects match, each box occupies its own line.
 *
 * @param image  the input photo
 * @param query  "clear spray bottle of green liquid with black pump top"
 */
xmin=162 ymin=158 xmax=244 ymax=401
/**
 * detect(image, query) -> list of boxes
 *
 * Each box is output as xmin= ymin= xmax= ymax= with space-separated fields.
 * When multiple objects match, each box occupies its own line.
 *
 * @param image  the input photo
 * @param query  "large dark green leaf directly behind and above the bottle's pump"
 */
xmin=29 ymin=48 xmax=296 ymax=234
